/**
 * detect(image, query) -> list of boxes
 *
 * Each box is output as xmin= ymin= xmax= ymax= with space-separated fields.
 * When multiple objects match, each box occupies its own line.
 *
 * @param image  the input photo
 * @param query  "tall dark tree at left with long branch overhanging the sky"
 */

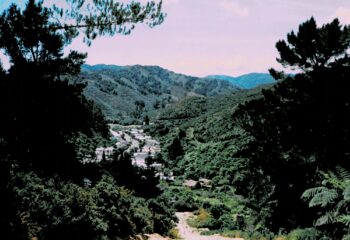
xmin=0 ymin=0 xmax=164 ymax=172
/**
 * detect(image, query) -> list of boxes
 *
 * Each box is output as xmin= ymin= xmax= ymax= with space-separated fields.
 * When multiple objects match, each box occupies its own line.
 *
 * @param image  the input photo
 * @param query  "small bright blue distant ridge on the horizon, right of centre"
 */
xmin=207 ymin=73 xmax=276 ymax=89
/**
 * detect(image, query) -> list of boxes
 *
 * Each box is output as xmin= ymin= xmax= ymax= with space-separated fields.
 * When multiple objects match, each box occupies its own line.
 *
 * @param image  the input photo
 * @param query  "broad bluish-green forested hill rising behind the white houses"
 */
xmin=75 ymin=64 xmax=238 ymax=121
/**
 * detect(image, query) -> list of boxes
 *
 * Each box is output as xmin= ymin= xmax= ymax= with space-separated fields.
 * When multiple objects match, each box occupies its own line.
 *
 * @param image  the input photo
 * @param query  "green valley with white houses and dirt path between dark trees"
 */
xmin=76 ymin=66 xmax=288 ymax=240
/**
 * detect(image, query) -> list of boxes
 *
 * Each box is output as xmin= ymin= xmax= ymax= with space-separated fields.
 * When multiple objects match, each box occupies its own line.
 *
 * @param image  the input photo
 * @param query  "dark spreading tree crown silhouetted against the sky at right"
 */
xmin=276 ymin=17 xmax=350 ymax=71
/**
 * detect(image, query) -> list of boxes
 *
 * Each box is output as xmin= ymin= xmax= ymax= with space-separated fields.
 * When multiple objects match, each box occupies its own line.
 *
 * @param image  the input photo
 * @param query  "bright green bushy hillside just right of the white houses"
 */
xmin=149 ymin=85 xmax=271 ymax=178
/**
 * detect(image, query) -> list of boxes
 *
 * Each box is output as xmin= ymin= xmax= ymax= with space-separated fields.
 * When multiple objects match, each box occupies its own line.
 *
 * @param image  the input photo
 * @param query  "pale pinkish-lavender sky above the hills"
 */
xmin=0 ymin=0 xmax=350 ymax=76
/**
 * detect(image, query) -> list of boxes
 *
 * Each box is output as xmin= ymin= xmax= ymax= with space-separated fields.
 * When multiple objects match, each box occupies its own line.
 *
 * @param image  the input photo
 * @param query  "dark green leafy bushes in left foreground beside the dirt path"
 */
xmin=12 ymin=173 xmax=167 ymax=240
